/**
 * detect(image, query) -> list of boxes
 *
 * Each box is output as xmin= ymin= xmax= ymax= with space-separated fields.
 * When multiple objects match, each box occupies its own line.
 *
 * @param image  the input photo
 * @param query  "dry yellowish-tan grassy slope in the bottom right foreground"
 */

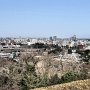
xmin=34 ymin=79 xmax=90 ymax=90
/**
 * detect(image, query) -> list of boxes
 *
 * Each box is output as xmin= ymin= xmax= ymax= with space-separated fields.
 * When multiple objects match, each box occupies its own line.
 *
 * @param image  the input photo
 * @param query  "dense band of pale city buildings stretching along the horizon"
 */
xmin=0 ymin=35 xmax=90 ymax=49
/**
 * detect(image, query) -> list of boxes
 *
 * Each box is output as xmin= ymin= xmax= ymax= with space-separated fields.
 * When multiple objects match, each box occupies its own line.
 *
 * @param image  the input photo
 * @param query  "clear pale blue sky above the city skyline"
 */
xmin=0 ymin=0 xmax=90 ymax=38
